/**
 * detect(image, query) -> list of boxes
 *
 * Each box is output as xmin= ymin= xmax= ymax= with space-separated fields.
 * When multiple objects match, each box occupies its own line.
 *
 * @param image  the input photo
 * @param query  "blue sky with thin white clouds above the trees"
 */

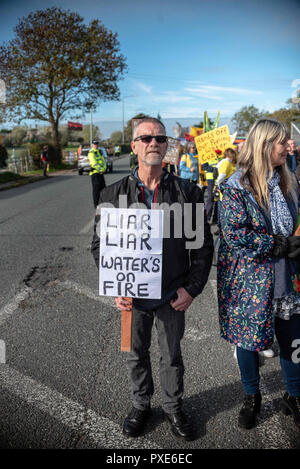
xmin=0 ymin=0 xmax=300 ymax=135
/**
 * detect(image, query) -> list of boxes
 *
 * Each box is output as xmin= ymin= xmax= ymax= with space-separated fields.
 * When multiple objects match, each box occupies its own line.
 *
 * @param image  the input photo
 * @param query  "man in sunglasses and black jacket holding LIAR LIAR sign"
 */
xmin=92 ymin=118 xmax=213 ymax=440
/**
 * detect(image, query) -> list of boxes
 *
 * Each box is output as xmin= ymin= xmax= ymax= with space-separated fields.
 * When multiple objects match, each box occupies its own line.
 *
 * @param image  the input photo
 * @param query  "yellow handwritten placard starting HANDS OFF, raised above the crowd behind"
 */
xmin=195 ymin=125 xmax=235 ymax=164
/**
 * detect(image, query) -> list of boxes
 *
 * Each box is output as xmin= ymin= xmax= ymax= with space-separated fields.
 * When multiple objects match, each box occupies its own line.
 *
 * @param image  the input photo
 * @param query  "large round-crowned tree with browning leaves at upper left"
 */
xmin=0 ymin=7 xmax=126 ymax=161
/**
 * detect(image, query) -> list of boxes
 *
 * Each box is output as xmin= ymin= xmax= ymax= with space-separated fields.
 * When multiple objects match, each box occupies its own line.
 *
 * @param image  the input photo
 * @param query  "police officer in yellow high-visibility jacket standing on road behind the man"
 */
xmin=88 ymin=140 xmax=106 ymax=208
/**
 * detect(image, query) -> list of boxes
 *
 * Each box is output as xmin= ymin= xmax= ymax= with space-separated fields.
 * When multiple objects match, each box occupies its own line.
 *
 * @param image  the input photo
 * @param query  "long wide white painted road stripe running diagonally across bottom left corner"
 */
xmin=0 ymin=365 xmax=161 ymax=449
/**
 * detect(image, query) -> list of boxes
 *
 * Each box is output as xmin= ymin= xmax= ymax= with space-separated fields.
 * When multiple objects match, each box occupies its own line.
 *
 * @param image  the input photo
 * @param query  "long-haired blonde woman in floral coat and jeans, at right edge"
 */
xmin=218 ymin=119 xmax=300 ymax=428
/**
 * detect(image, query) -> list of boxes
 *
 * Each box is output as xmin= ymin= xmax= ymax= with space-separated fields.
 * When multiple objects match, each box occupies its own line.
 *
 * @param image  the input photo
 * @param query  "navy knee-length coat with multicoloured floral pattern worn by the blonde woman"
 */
xmin=217 ymin=173 xmax=274 ymax=351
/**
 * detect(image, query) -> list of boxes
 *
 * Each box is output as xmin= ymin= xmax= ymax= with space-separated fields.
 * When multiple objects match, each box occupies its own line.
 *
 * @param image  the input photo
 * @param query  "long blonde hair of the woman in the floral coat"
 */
xmin=238 ymin=119 xmax=296 ymax=208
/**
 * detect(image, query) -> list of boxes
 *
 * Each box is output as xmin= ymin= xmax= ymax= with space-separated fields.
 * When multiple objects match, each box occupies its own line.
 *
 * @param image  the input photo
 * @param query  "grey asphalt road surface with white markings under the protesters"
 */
xmin=0 ymin=157 xmax=300 ymax=454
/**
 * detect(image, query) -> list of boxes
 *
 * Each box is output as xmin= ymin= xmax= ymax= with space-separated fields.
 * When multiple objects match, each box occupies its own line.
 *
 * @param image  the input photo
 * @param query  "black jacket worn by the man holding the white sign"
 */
xmin=91 ymin=171 xmax=214 ymax=301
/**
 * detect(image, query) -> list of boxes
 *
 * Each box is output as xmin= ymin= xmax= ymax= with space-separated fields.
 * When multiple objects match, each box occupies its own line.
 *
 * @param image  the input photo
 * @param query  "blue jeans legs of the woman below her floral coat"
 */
xmin=237 ymin=314 xmax=300 ymax=397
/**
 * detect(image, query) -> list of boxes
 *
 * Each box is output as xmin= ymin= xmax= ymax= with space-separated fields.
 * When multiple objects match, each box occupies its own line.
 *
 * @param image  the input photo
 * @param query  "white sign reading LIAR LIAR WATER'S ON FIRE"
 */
xmin=99 ymin=207 xmax=163 ymax=299
